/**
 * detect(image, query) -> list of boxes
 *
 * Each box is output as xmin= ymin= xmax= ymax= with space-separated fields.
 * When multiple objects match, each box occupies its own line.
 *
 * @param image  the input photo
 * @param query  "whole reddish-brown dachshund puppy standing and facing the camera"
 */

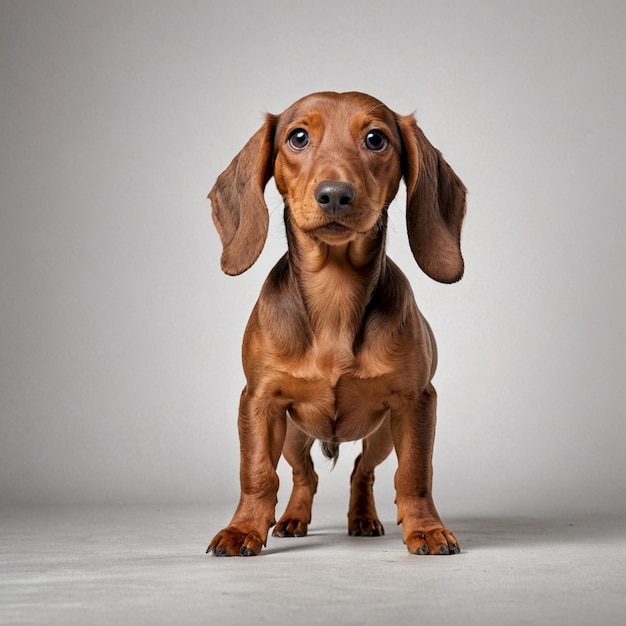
xmin=207 ymin=92 xmax=465 ymax=556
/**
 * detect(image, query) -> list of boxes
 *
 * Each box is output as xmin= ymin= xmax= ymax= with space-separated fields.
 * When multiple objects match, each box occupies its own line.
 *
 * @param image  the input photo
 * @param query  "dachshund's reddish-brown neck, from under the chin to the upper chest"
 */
xmin=285 ymin=208 xmax=386 ymax=339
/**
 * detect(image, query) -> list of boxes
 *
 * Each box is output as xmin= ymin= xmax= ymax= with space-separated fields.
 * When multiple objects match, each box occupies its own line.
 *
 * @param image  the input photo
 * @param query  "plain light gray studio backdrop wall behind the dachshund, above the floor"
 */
xmin=0 ymin=0 xmax=626 ymax=513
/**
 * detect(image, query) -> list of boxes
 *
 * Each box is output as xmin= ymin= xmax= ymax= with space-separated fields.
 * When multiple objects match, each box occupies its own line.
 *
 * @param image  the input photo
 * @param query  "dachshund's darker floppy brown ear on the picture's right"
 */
xmin=398 ymin=115 xmax=466 ymax=283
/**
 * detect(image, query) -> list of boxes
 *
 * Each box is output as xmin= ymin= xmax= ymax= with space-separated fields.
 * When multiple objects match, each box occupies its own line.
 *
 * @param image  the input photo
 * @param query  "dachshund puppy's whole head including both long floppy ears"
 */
xmin=209 ymin=92 xmax=466 ymax=283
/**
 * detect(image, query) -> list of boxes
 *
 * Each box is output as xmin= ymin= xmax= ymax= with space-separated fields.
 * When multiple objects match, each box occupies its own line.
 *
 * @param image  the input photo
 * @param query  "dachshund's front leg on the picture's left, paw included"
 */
xmin=207 ymin=388 xmax=286 ymax=556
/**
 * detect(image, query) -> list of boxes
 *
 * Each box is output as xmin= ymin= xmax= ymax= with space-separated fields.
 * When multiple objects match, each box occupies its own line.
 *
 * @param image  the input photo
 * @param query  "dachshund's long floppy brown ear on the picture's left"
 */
xmin=209 ymin=115 xmax=277 ymax=276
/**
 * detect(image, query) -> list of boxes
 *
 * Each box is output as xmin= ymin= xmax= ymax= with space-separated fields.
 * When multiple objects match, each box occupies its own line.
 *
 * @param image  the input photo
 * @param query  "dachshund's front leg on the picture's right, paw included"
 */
xmin=391 ymin=385 xmax=460 ymax=554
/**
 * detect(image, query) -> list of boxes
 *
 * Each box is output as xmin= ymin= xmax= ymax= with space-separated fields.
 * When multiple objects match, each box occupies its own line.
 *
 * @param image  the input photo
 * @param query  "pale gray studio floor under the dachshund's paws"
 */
xmin=0 ymin=503 xmax=626 ymax=626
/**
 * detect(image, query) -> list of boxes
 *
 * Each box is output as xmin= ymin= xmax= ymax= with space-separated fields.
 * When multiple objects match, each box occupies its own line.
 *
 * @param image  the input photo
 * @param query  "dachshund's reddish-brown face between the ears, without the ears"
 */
xmin=274 ymin=93 xmax=402 ymax=245
